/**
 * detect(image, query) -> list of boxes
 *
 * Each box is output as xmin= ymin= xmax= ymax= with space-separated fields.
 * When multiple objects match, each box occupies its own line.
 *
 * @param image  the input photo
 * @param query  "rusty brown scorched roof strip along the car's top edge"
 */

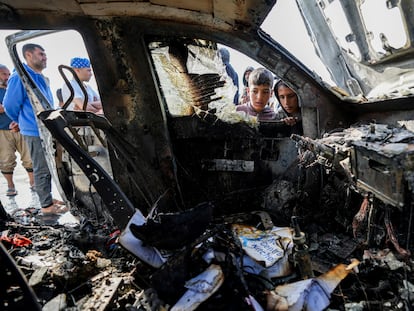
xmin=2 ymin=0 xmax=276 ymax=28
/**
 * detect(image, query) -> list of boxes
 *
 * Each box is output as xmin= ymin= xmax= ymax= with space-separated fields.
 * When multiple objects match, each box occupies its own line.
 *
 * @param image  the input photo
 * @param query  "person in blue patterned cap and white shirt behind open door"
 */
xmin=62 ymin=57 xmax=103 ymax=114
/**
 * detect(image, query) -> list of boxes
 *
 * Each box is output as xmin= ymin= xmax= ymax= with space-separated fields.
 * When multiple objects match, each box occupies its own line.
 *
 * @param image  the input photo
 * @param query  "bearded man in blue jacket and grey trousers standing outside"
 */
xmin=3 ymin=43 xmax=68 ymax=215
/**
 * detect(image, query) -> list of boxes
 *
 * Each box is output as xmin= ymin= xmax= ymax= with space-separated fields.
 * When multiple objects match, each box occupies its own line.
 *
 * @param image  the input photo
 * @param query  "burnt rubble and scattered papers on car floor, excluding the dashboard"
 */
xmin=1 ymin=205 xmax=414 ymax=310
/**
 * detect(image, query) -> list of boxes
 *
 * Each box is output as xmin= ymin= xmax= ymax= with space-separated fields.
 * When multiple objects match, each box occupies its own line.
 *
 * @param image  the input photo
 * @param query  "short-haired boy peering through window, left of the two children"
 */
xmin=236 ymin=68 xmax=276 ymax=121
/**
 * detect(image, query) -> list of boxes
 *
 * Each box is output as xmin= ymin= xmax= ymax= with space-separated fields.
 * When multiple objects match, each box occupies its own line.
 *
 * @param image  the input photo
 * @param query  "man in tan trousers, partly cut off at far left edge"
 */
xmin=0 ymin=64 xmax=34 ymax=197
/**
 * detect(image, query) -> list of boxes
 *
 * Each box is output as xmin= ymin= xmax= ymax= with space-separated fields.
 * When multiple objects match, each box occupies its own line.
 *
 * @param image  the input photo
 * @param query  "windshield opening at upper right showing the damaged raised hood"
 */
xmin=263 ymin=0 xmax=414 ymax=102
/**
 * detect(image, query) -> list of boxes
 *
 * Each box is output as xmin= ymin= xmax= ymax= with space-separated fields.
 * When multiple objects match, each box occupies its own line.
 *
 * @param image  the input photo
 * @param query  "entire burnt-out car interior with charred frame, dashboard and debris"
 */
xmin=0 ymin=0 xmax=414 ymax=310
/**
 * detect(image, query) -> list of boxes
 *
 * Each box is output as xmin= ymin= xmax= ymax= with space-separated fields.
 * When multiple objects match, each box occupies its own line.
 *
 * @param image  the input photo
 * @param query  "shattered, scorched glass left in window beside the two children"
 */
xmin=149 ymin=39 xmax=254 ymax=125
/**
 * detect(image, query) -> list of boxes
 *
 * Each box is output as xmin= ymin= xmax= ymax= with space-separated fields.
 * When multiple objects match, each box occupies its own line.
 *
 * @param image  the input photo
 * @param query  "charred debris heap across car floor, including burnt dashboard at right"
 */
xmin=0 ymin=126 xmax=414 ymax=311
